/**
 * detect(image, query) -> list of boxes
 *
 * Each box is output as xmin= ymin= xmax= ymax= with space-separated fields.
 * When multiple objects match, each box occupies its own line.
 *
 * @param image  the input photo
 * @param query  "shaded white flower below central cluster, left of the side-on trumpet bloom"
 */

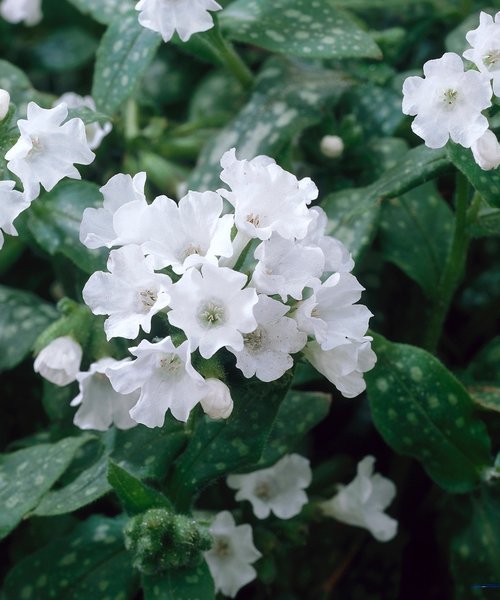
xmin=226 ymin=454 xmax=312 ymax=519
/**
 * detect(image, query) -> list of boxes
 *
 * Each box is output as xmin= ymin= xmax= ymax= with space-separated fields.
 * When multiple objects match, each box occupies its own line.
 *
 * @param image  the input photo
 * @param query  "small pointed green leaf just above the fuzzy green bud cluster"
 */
xmin=108 ymin=461 xmax=172 ymax=515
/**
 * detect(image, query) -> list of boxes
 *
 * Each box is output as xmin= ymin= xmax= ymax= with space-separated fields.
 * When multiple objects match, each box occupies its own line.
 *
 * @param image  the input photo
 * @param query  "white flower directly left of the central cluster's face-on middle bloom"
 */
xmin=82 ymin=245 xmax=172 ymax=340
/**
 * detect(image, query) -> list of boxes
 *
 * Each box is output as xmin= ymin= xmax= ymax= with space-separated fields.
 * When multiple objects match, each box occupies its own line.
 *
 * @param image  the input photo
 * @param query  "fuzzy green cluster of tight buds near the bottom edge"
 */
xmin=124 ymin=508 xmax=212 ymax=575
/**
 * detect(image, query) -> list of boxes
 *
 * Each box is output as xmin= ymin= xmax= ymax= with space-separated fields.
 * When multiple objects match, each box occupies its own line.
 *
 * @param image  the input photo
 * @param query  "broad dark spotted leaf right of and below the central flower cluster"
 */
xmin=366 ymin=335 xmax=491 ymax=493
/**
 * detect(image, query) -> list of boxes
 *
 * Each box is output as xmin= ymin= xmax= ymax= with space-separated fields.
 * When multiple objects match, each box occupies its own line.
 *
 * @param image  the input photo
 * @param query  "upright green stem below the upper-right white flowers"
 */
xmin=422 ymin=173 xmax=475 ymax=353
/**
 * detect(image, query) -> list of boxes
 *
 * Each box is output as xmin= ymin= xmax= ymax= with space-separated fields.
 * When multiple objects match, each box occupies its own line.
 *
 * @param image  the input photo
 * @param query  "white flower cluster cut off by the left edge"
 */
xmin=0 ymin=99 xmax=95 ymax=248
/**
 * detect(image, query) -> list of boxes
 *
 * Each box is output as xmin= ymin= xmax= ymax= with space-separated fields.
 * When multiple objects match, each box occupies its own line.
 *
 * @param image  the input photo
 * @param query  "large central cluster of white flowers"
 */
xmin=68 ymin=149 xmax=375 ymax=427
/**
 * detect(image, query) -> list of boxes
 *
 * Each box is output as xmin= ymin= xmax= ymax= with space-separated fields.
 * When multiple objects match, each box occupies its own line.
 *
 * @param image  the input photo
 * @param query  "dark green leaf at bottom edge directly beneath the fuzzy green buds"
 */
xmin=142 ymin=563 xmax=215 ymax=600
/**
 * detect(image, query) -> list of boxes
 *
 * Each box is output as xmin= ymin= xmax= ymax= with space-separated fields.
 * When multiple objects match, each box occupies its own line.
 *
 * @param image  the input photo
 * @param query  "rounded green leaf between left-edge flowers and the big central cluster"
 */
xmin=27 ymin=181 xmax=108 ymax=274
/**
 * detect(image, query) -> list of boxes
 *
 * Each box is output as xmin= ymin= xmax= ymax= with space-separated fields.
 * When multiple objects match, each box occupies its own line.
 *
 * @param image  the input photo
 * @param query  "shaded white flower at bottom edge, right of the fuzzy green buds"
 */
xmin=203 ymin=510 xmax=262 ymax=598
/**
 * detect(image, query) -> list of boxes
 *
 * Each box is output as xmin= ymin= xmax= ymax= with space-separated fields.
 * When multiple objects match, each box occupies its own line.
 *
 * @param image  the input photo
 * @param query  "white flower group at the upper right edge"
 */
xmin=403 ymin=12 xmax=500 ymax=170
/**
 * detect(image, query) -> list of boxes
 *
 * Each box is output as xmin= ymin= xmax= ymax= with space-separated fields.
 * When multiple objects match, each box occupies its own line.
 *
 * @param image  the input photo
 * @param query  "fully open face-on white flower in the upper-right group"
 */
xmin=403 ymin=52 xmax=492 ymax=148
